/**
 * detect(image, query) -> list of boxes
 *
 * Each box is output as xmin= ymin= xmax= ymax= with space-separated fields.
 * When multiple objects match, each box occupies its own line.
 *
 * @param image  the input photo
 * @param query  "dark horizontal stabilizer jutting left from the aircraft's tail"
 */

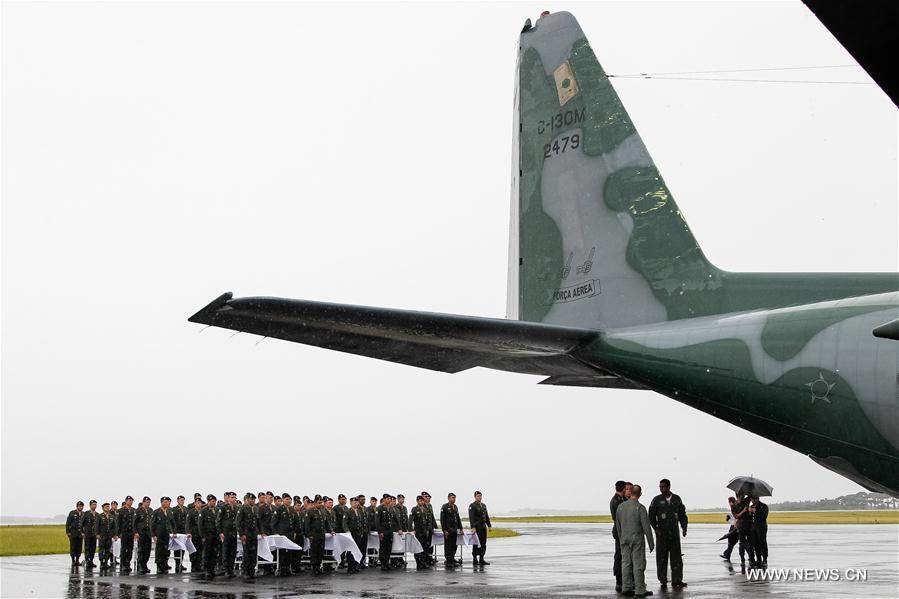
xmin=189 ymin=293 xmax=608 ymax=377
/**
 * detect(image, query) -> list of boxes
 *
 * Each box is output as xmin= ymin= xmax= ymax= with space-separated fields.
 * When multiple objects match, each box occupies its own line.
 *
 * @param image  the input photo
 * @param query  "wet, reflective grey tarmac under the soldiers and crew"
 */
xmin=0 ymin=524 xmax=899 ymax=599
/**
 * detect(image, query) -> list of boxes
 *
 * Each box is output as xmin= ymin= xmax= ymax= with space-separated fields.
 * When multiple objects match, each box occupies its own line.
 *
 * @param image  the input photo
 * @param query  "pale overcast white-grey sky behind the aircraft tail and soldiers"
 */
xmin=0 ymin=2 xmax=899 ymax=516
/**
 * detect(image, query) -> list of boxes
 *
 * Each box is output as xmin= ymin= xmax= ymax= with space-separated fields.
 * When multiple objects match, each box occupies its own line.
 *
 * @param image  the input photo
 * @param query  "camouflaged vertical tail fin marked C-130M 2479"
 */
xmin=508 ymin=12 xmax=722 ymax=328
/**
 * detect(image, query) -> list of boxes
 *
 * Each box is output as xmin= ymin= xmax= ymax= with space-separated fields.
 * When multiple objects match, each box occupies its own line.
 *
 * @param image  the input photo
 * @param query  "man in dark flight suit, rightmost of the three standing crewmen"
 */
xmin=649 ymin=478 xmax=687 ymax=589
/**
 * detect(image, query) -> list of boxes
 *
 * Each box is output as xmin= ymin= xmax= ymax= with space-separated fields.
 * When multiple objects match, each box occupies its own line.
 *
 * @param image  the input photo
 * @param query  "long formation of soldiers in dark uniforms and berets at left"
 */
xmin=66 ymin=491 xmax=492 ymax=579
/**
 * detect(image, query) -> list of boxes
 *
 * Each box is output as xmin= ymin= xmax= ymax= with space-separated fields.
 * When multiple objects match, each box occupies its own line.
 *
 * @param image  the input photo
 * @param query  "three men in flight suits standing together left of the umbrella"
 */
xmin=609 ymin=478 xmax=687 ymax=597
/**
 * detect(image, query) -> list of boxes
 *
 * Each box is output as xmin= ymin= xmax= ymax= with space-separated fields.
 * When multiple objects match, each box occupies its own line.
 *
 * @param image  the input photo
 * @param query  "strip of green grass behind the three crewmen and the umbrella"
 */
xmin=491 ymin=510 xmax=899 ymax=524
